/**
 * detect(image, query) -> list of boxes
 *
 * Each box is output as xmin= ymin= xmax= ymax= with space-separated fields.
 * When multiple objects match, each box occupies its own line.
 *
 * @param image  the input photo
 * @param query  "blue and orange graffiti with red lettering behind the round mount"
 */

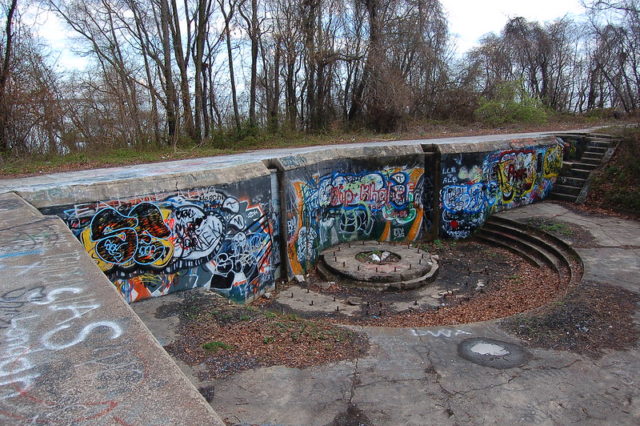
xmin=287 ymin=166 xmax=424 ymax=274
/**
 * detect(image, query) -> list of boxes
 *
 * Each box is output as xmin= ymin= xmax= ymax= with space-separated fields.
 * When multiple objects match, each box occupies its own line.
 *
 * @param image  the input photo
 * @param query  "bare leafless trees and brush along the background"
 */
xmin=0 ymin=0 xmax=640 ymax=160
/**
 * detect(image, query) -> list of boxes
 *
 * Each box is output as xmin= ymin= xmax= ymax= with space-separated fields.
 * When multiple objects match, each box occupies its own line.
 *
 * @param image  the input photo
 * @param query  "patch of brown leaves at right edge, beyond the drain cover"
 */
xmin=503 ymin=282 xmax=640 ymax=357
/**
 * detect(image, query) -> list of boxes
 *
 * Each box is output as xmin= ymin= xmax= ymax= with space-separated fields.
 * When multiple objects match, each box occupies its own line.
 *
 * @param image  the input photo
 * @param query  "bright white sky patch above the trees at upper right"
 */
xmin=440 ymin=0 xmax=584 ymax=53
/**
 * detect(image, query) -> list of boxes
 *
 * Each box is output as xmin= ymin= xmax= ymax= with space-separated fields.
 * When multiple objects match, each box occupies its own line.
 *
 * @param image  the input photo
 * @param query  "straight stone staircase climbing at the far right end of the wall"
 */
xmin=549 ymin=134 xmax=618 ymax=203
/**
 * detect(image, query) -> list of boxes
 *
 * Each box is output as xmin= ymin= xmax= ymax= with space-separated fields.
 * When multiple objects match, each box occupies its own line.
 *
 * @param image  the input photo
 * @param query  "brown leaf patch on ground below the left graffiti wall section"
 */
xmin=165 ymin=292 xmax=368 ymax=378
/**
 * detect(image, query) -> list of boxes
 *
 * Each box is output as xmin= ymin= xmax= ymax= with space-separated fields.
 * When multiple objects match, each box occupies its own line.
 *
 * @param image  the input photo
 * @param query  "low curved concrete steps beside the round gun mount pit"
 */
xmin=475 ymin=216 xmax=583 ymax=286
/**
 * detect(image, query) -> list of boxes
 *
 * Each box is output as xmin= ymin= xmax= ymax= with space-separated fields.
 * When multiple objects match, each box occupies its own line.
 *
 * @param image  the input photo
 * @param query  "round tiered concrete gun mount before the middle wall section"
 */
xmin=321 ymin=241 xmax=438 ymax=290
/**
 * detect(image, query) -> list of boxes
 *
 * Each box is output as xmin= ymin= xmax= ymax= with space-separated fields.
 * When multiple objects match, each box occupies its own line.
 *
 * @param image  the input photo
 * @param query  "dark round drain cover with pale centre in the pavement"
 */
xmin=458 ymin=337 xmax=531 ymax=369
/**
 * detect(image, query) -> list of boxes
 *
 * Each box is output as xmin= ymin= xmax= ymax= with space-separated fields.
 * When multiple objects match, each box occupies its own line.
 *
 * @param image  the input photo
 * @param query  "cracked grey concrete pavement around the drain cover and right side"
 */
xmin=138 ymin=202 xmax=640 ymax=425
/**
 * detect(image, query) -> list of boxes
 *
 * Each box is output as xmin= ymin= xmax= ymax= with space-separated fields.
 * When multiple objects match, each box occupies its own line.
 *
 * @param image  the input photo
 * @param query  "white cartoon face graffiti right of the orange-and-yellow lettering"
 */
xmin=174 ymin=205 xmax=225 ymax=260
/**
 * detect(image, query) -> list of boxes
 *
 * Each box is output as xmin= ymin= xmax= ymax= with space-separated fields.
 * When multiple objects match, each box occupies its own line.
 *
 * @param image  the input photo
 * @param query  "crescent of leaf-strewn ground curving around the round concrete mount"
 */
xmin=261 ymin=240 xmax=566 ymax=327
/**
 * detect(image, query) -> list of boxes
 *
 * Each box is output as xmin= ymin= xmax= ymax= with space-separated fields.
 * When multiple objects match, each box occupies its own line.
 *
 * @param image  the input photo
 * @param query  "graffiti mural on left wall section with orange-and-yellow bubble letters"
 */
xmin=57 ymin=182 xmax=275 ymax=302
